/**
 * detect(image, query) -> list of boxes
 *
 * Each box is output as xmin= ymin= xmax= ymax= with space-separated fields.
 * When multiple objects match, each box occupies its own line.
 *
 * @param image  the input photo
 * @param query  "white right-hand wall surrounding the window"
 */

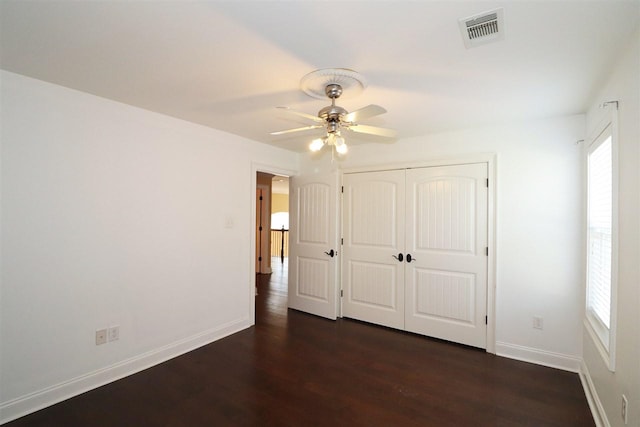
xmin=584 ymin=31 xmax=640 ymax=426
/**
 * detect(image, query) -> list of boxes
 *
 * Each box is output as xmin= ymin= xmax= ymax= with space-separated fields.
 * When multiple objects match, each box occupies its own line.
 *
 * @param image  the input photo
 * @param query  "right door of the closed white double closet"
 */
xmin=405 ymin=163 xmax=488 ymax=348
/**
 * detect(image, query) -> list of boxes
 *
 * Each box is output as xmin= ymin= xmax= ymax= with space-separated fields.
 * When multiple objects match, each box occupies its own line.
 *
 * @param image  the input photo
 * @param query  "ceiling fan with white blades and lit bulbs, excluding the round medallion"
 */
xmin=271 ymin=83 xmax=396 ymax=154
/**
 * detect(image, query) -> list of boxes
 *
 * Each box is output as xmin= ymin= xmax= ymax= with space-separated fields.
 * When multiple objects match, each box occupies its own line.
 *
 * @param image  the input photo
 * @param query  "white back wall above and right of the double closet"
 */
xmin=301 ymin=115 xmax=585 ymax=371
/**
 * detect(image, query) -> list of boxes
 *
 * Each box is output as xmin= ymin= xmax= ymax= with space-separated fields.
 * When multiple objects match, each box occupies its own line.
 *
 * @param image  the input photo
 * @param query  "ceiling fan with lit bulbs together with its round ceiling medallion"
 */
xmin=271 ymin=68 xmax=396 ymax=155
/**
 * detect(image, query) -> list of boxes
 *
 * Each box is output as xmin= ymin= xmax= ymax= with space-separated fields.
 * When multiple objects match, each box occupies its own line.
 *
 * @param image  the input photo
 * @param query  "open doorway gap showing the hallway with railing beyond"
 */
xmin=255 ymin=171 xmax=289 ymax=323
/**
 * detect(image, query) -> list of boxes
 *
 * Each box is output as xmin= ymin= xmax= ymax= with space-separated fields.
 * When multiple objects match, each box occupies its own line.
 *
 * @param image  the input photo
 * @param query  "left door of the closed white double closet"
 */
xmin=342 ymin=170 xmax=405 ymax=329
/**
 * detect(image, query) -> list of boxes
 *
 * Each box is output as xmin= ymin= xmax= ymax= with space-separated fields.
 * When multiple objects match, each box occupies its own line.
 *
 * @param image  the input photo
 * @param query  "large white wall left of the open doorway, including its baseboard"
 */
xmin=0 ymin=71 xmax=298 ymax=422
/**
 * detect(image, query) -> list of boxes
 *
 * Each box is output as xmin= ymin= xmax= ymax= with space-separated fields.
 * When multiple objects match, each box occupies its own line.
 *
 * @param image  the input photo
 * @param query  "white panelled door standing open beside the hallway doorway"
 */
xmin=288 ymin=174 xmax=338 ymax=319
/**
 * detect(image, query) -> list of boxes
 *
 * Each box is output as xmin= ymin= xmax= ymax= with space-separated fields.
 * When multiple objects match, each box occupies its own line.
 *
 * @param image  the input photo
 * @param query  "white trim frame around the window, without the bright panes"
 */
xmin=584 ymin=108 xmax=619 ymax=372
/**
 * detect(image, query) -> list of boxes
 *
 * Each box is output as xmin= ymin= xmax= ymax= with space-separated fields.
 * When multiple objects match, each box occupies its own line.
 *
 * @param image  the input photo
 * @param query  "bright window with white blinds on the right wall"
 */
xmin=586 ymin=118 xmax=617 ymax=371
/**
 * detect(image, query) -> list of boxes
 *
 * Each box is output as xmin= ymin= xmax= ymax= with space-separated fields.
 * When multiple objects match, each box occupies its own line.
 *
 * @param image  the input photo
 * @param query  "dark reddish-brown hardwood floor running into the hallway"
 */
xmin=8 ymin=259 xmax=594 ymax=427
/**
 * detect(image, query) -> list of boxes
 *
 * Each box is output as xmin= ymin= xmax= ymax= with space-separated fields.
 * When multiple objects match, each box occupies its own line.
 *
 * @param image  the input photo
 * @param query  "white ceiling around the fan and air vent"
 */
xmin=0 ymin=0 xmax=640 ymax=151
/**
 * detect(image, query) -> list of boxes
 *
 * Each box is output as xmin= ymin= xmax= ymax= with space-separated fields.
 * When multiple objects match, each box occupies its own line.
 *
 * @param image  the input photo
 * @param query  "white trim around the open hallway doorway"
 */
xmin=249 ymin=162 xmax=298 ymax=325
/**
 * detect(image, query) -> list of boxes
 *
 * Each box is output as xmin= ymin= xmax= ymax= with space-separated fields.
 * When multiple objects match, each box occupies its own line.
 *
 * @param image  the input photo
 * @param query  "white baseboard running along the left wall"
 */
xmin=0 ymin=319 xmax=251 ymax=424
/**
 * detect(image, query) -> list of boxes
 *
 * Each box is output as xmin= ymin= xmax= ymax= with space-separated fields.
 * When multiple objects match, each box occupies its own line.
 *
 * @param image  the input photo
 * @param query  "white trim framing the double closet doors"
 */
xmin=338 ymin=153 xmax=498 ymax=354
